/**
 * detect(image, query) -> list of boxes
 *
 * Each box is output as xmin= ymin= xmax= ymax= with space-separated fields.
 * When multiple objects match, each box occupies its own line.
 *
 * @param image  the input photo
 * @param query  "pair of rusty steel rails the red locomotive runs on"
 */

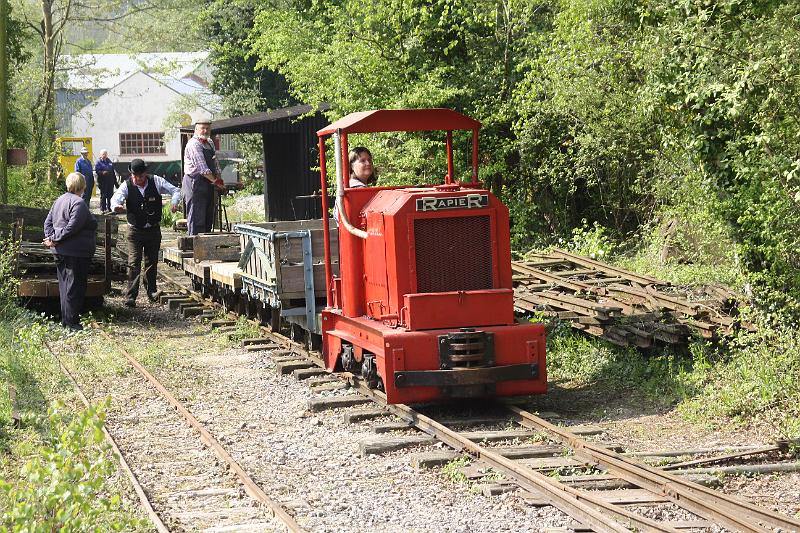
xmin=153 ymin=273 xmax=800 ymax=533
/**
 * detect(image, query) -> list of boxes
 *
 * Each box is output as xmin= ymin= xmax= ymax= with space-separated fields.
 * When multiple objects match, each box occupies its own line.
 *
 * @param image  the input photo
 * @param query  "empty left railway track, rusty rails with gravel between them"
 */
xmin=48 ymin=314 xmax=306 ymax=533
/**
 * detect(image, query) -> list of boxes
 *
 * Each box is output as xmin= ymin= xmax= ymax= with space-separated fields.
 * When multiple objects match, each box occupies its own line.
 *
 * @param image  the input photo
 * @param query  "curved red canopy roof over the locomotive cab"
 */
xmin=317 ymin=108 xmax=481 ymax=137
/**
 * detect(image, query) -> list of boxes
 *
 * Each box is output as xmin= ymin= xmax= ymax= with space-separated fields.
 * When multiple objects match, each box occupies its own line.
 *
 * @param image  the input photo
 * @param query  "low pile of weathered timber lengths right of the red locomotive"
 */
xmin=511 ymin=249 xmax=752 ymax=348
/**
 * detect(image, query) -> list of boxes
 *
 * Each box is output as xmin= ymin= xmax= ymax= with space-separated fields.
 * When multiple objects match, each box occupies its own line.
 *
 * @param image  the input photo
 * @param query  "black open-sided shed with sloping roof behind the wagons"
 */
xmin=181 ymin=104 xmax=328 ymax=221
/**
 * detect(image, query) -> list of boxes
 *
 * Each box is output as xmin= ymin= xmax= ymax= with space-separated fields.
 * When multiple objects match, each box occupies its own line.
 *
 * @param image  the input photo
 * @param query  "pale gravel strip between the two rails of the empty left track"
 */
xmin=57 ymin=316 xmax=281 ymax=533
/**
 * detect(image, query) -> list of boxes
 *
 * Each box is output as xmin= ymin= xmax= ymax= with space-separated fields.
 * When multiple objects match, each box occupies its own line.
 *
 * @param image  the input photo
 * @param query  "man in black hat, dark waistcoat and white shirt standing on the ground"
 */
xmin=111 ymin=159 xmax=181 ymax=307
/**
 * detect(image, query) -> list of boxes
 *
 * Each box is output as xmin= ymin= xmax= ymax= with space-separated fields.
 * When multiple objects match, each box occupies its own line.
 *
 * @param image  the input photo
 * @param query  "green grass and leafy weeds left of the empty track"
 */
xmin=0 ymin=312 xmax=148 ymax=531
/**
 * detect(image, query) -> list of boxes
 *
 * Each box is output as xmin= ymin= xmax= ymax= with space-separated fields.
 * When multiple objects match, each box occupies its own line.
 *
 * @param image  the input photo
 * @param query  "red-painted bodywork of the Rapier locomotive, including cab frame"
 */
xmin=317 ymin=109 xmax=547 ymax=403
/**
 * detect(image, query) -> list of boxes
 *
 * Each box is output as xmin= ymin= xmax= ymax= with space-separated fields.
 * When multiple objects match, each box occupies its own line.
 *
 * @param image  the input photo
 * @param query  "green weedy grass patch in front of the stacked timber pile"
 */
xmin=536 ymin=272 xmax=800 ymax=439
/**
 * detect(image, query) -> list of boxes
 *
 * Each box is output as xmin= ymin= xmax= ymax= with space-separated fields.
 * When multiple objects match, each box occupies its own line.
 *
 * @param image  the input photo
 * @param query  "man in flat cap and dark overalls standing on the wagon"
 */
xmin=181 ymin=117 xmax=225 ymax=235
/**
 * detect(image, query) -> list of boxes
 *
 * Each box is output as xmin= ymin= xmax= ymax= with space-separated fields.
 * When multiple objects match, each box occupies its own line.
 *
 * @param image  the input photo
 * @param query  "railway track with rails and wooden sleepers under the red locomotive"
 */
xmin=156 ymin=273 xmax=800 ymax=532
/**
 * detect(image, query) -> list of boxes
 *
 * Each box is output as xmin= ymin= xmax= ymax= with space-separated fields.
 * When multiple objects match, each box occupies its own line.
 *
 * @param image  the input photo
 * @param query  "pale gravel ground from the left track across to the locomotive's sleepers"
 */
xmin=65 ymin=286 xmax=572 ymax=532
